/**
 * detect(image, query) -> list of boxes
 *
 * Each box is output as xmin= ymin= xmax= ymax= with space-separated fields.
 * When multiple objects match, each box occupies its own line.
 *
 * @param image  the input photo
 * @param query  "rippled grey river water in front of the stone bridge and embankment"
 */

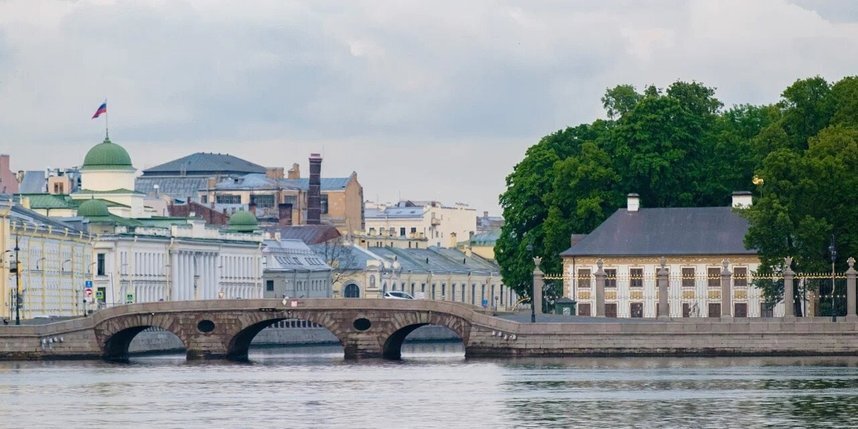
xmin=0 ymin=343 xmax=858 ymax=429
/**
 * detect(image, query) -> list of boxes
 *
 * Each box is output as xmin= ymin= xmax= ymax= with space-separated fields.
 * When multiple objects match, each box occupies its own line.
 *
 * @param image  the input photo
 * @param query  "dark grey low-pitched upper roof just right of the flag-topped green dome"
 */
xmin=143 ymin=152 xmax=266 ymax=176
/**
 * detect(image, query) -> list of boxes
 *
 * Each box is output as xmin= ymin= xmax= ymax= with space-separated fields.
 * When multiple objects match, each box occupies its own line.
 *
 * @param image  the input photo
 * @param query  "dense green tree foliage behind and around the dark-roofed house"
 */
xmin=495 ymin=77 xmax=858 ymax=296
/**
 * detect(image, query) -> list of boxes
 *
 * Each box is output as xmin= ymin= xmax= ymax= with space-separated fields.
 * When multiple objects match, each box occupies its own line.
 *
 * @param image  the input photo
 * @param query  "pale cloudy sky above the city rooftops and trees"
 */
xmin=0 ymin=0 xmax=858 ymax=215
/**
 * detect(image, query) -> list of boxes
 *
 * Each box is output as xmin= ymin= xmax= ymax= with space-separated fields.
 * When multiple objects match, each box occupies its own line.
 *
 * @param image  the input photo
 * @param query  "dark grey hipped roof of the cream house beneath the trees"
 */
xmin=560 ymin=207 xmax=757 ymax=256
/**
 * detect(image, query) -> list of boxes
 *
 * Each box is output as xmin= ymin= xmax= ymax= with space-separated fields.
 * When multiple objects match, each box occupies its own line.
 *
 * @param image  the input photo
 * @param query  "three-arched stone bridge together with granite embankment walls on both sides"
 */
xmin=0 ymin=299 xmax=858 ymax=361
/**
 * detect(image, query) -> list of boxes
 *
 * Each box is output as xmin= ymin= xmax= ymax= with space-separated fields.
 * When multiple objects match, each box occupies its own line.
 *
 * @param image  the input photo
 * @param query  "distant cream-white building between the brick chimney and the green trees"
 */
xmin=364 ymin=201 xmax=477 ymax=248
